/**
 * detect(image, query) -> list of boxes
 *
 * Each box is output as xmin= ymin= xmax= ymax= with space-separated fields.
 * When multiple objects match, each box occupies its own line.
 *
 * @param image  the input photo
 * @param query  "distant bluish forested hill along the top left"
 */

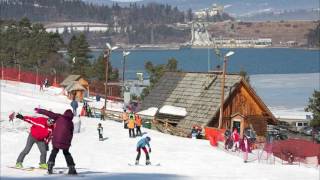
xmin=0 ymin=0 xmax=185 ymax=25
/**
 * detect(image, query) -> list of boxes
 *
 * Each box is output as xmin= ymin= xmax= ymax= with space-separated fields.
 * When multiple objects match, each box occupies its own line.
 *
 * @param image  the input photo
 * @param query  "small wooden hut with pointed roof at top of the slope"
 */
xmin=60 ymin=75 xmax=89 ymax=101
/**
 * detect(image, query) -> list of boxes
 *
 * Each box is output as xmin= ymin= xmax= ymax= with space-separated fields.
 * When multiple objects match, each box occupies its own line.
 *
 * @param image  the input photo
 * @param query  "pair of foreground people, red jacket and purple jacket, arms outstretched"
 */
xmin=16 ymin=108 xmax=77 ymax=175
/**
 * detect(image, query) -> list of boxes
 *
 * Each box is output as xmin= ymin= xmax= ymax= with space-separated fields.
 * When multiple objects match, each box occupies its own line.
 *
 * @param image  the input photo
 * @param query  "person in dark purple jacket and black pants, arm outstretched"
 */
xmin=35 ymin=108 xmax=77 ymax=175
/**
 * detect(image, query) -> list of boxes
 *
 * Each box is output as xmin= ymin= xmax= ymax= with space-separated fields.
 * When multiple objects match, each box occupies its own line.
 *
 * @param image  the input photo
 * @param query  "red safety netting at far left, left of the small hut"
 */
xmin=0 ymin=67 xmax=63 ymax=86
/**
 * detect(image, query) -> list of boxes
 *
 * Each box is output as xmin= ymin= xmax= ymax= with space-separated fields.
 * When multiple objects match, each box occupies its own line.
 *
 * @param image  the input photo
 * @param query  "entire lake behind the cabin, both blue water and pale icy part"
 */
xmin=93 ymin=48 xmax=320 ymax=118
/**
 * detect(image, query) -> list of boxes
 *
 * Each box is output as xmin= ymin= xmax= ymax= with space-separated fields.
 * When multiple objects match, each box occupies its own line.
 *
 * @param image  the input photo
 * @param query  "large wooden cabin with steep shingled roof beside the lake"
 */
xmin=141 ymin=72 xmax=277 ymax=139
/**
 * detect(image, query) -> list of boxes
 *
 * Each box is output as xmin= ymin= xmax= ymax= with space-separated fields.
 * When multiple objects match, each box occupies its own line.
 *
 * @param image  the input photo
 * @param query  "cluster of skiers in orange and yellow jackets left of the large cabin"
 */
xmin=122 ymin=110 xmax=142 ymax=138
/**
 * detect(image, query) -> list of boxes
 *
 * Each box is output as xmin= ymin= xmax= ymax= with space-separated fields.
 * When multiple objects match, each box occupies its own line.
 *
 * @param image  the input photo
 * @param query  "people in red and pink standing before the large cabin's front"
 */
xmin=224 ymin=128 xmax=251 ymax=163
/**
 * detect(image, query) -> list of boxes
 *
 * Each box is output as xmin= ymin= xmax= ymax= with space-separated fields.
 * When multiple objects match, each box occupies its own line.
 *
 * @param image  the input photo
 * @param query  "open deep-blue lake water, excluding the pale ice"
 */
xmin=92 ymin=48 xmax=320 ymax=79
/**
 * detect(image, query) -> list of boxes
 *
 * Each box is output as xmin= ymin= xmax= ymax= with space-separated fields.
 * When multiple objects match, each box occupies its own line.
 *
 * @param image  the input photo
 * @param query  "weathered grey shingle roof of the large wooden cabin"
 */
xmin=142 ymin=72 xmax=276 ymax=130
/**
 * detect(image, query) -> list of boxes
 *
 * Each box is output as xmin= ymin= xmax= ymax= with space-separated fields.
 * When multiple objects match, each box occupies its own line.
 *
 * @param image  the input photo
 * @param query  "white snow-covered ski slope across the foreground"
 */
xmin=0 ymin=81 xmax=319 ymax=180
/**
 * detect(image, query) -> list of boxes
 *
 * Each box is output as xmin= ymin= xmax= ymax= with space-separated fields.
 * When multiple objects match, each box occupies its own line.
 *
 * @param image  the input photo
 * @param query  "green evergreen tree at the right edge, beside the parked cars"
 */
xmin=305 ymin=90 xmax=320 ymax=127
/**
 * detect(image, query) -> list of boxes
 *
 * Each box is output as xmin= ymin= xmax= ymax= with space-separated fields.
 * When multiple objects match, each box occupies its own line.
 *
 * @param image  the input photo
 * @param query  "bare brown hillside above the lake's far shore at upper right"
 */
xmin=208 ymin=21 xmax=319 ymax=46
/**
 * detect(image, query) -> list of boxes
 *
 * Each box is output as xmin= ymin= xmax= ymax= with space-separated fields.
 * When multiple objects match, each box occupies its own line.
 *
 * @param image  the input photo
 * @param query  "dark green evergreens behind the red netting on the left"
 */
xmin=0 ymin=18 xmax=118 ymax=81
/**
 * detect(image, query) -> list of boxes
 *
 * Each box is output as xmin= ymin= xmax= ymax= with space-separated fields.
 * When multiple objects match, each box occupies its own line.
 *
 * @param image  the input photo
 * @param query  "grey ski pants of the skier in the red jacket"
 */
xmin=17 ymin=134 xmax=47 ymax=164
